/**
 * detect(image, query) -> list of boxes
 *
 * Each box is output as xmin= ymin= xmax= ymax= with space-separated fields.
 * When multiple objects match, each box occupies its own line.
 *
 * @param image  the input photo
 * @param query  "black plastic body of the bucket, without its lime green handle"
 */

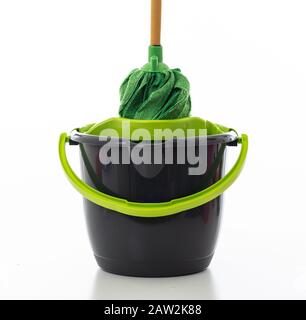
xmin=59 ymin=117 xmax=249 ymax=277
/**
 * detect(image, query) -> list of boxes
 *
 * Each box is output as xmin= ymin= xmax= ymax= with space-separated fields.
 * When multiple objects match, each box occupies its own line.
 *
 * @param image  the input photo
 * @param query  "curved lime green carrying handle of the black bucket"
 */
xmin=59 ymin=133 xmax=248 ymax=218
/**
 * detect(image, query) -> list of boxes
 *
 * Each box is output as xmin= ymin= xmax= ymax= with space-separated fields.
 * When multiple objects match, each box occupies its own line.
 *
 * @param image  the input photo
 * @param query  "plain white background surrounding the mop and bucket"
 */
xmin=0 ymin=0 xmax=306 ymax=299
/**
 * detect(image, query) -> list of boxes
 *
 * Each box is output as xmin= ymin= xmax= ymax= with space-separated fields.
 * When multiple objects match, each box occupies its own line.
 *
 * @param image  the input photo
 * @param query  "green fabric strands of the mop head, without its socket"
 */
xmin=119 ymin=68 xmax=191 ymax=120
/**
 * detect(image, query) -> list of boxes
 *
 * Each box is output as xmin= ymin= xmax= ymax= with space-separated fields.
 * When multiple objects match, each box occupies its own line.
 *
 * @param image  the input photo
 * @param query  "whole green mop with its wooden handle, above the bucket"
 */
xmin=119 ymin=0 xmax=191 ymax=120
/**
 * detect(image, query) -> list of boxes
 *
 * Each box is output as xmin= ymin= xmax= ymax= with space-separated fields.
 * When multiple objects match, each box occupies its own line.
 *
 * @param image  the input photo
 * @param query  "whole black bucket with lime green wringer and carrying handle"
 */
xmin=59 ymin=118 xmax=248 ymax=277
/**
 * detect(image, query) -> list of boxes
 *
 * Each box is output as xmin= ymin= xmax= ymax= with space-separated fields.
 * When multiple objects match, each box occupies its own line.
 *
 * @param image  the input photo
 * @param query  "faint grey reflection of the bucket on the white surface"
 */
xmin=91 ymin=270 xmax=218 ymax=300
